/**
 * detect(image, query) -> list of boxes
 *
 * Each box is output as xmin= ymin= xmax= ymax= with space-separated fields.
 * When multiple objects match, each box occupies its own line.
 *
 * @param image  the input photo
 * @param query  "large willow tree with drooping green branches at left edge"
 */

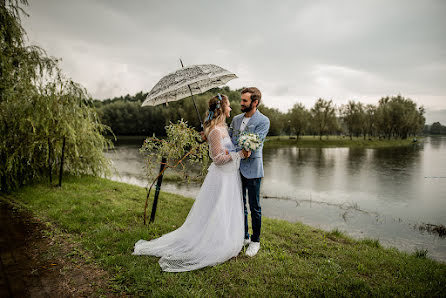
xmin=0 ymin=0 xmax=111 ymax=191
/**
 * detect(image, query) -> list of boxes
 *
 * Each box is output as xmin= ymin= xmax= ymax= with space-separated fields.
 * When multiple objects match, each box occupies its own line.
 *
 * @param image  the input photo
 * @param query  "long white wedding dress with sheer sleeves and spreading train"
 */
xmin=133 ymin=127 xmax=244 ymax=272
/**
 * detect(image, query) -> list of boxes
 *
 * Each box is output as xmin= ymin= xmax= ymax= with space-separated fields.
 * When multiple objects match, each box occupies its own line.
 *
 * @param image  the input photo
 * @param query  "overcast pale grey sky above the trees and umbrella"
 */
xmin=23 ymin=0 xmax=446 ymax=124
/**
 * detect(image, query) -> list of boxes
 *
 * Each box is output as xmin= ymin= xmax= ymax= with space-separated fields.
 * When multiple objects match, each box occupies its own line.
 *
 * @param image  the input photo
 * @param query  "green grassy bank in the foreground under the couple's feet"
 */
xmin=0 ymin=177 xmax=446 ymax=297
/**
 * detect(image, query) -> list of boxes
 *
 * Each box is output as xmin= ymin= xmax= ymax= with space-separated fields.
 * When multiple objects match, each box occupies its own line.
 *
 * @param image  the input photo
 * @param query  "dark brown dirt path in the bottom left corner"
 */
xmin=0 ymin=200 xmax=122 ymax=297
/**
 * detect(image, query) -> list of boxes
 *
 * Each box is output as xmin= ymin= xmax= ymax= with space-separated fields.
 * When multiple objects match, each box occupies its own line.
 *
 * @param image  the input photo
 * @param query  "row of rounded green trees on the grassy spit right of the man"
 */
xmin=285 ymin=95 xmax=426 ymax=139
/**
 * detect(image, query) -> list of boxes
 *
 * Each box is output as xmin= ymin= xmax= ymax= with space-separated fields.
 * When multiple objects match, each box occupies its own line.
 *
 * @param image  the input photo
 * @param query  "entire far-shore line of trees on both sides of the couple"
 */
xmin=94 ymin=87 xmax=425 ymax=139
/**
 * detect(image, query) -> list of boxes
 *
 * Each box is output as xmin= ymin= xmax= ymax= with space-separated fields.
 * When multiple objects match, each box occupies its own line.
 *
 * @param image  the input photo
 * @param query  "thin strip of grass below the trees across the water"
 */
xmin=265 ymin=136 xmax=422 ymax=148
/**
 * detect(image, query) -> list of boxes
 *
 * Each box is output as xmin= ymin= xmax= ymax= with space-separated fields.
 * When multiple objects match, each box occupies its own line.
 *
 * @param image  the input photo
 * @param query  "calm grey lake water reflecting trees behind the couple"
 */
xmin=106 ymin=137 xmax=446 ymax=262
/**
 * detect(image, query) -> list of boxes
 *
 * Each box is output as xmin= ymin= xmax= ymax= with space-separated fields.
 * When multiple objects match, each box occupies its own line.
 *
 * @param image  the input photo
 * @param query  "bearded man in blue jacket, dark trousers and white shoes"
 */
xmin=229 ymin=87 xmax=269 ymax=257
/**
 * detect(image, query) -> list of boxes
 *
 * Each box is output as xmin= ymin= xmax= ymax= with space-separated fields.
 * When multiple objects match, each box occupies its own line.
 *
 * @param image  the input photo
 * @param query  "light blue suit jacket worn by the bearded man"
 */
xmin=229 ymin=110 xmax=270 ymax=179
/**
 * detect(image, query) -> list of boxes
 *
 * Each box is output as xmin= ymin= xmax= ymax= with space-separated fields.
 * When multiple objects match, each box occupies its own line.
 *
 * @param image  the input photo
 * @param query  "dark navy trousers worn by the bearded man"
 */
xmin=241 ymin=175 xmax=262 ymax=242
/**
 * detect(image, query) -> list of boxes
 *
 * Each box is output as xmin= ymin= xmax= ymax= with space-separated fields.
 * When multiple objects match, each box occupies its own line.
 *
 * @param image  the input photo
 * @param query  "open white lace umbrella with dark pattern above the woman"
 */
xmin=142 ymin=59 xmax=237 ymax=127
